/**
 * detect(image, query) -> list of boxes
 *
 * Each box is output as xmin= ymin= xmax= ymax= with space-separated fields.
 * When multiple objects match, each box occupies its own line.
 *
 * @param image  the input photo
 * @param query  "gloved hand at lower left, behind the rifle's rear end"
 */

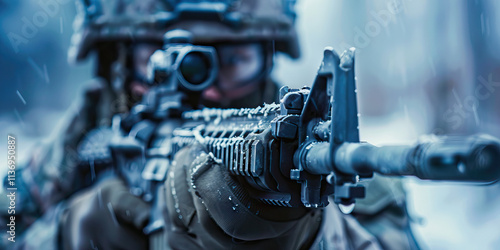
xmin=60 ymin=179 xmax=148 ymax=249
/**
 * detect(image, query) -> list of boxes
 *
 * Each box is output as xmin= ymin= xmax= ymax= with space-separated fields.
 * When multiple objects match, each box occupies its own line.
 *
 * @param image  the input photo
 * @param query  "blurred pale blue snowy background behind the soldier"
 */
xmin=0 ymin=0 xmax=500 ymax=249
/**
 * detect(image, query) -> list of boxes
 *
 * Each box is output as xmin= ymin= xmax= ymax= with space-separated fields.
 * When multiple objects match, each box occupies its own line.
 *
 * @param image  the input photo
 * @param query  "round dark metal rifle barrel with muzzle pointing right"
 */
xmin=303 ymin=135 xmax=500 ymax=182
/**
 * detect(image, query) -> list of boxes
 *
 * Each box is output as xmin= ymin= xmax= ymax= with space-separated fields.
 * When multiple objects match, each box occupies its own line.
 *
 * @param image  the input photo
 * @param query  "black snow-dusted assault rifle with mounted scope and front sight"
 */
xmin=112 ymin=30 xmax=500 ymax=239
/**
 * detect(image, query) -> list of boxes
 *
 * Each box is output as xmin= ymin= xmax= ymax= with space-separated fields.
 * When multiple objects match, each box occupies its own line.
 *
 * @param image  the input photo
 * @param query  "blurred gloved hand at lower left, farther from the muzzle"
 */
xmin=59 ymin=177 xmax=150 ymax=250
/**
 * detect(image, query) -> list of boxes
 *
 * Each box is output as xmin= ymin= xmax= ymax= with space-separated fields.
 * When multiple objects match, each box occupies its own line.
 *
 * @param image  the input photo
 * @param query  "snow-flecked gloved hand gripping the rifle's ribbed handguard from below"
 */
xmin=165 ymin=145 xmax=323 ymax=249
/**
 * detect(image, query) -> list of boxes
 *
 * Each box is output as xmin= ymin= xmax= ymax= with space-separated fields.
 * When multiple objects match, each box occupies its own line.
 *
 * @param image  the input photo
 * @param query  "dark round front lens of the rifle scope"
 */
xmin=180 ymin=52 xmax=210 ymax=85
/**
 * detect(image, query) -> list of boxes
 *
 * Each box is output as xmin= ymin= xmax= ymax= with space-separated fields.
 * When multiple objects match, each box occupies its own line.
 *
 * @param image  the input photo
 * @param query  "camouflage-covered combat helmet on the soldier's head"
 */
xmin=68 ymin=0 xmax=300 ymax=62
